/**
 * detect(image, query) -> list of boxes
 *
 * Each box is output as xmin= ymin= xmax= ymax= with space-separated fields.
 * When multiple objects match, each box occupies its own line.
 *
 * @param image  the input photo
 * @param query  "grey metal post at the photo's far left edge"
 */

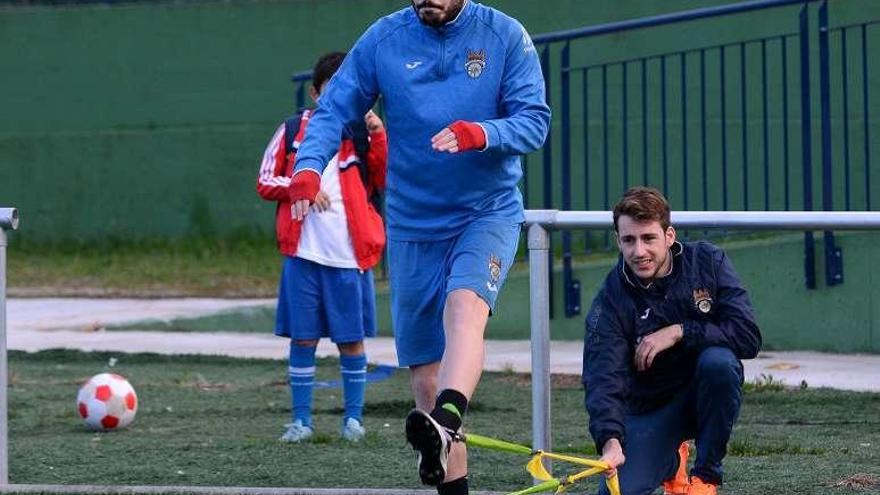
xmin=0 ymin=208 xmax=18 ymax=487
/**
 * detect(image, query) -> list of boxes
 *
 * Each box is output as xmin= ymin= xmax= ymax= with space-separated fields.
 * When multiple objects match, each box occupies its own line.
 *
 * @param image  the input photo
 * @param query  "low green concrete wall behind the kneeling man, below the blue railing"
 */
xmin=378 ymin=233 xmax=880 ymax=353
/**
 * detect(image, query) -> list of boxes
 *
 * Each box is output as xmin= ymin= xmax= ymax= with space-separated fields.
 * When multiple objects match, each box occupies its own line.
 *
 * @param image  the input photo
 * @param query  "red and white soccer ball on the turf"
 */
xmin=76 ymin=373 xmax=137 ymax=431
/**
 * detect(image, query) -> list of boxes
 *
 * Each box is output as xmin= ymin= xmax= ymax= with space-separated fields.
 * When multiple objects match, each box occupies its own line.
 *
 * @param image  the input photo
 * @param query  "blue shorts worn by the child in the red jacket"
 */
xmin=275 ymin=256 xmax=376 ymax=344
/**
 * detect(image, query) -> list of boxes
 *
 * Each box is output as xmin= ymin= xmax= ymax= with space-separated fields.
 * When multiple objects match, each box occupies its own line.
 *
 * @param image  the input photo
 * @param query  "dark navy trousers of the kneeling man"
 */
xmin=599 ymin=347 xmax=743 ymax=495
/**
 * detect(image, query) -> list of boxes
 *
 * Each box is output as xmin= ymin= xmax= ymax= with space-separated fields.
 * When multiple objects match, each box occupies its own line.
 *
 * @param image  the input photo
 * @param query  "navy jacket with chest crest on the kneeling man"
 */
xmin=583 ymin=242 xmax=761 ymax=452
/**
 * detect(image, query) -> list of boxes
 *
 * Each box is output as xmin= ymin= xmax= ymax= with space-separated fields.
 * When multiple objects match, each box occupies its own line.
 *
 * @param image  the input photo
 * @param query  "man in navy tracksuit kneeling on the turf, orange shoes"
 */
xmin=583 ymin=187 xmax=761 ymax=495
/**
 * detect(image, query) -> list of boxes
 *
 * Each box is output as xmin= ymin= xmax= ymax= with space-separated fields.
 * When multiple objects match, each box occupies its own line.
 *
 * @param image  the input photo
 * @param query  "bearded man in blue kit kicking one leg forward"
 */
xmin=290 ymin=0 xmax=550 ymax=494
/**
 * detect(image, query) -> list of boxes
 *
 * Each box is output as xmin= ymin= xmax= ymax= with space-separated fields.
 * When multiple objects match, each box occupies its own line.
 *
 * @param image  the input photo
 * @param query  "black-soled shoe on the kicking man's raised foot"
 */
xmin=406 ymin=409 xmax=455 ymax=486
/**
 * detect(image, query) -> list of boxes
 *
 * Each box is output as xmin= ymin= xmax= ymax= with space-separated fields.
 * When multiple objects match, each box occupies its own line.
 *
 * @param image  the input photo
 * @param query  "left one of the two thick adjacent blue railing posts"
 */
xmin=798 ymin=4 xmax=816 ymax=289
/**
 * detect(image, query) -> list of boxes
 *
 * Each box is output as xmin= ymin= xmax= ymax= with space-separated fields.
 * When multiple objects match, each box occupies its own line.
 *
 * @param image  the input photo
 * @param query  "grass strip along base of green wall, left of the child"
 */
xmin=7 ymin=234 xmax=281 ymax=297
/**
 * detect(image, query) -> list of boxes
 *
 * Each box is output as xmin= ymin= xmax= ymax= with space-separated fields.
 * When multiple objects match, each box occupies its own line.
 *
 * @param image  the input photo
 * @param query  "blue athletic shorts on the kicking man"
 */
xmin=387 ymin=220 xmax=522 ymax=366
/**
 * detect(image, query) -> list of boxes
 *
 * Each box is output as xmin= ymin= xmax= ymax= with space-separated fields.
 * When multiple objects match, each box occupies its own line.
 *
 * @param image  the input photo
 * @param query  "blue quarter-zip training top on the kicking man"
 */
xmin=295 ymin=1 xmax=550 ymax=241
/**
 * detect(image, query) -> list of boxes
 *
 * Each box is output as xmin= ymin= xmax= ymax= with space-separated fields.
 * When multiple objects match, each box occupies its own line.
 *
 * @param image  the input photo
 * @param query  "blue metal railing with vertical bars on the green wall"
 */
xmin=294 ymin=0 xmax=880 ymax=310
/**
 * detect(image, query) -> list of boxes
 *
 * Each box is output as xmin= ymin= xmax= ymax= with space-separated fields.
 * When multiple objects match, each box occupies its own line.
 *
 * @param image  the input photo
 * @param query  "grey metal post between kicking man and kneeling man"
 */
xmin=528 ymin=223 xmax=550 ymax=478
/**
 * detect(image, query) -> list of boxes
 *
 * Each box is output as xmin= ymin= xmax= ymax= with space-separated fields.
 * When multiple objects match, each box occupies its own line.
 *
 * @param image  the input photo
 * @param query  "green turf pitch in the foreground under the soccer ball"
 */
xmin=3 ymin=351 xmax=880 ymax=495
